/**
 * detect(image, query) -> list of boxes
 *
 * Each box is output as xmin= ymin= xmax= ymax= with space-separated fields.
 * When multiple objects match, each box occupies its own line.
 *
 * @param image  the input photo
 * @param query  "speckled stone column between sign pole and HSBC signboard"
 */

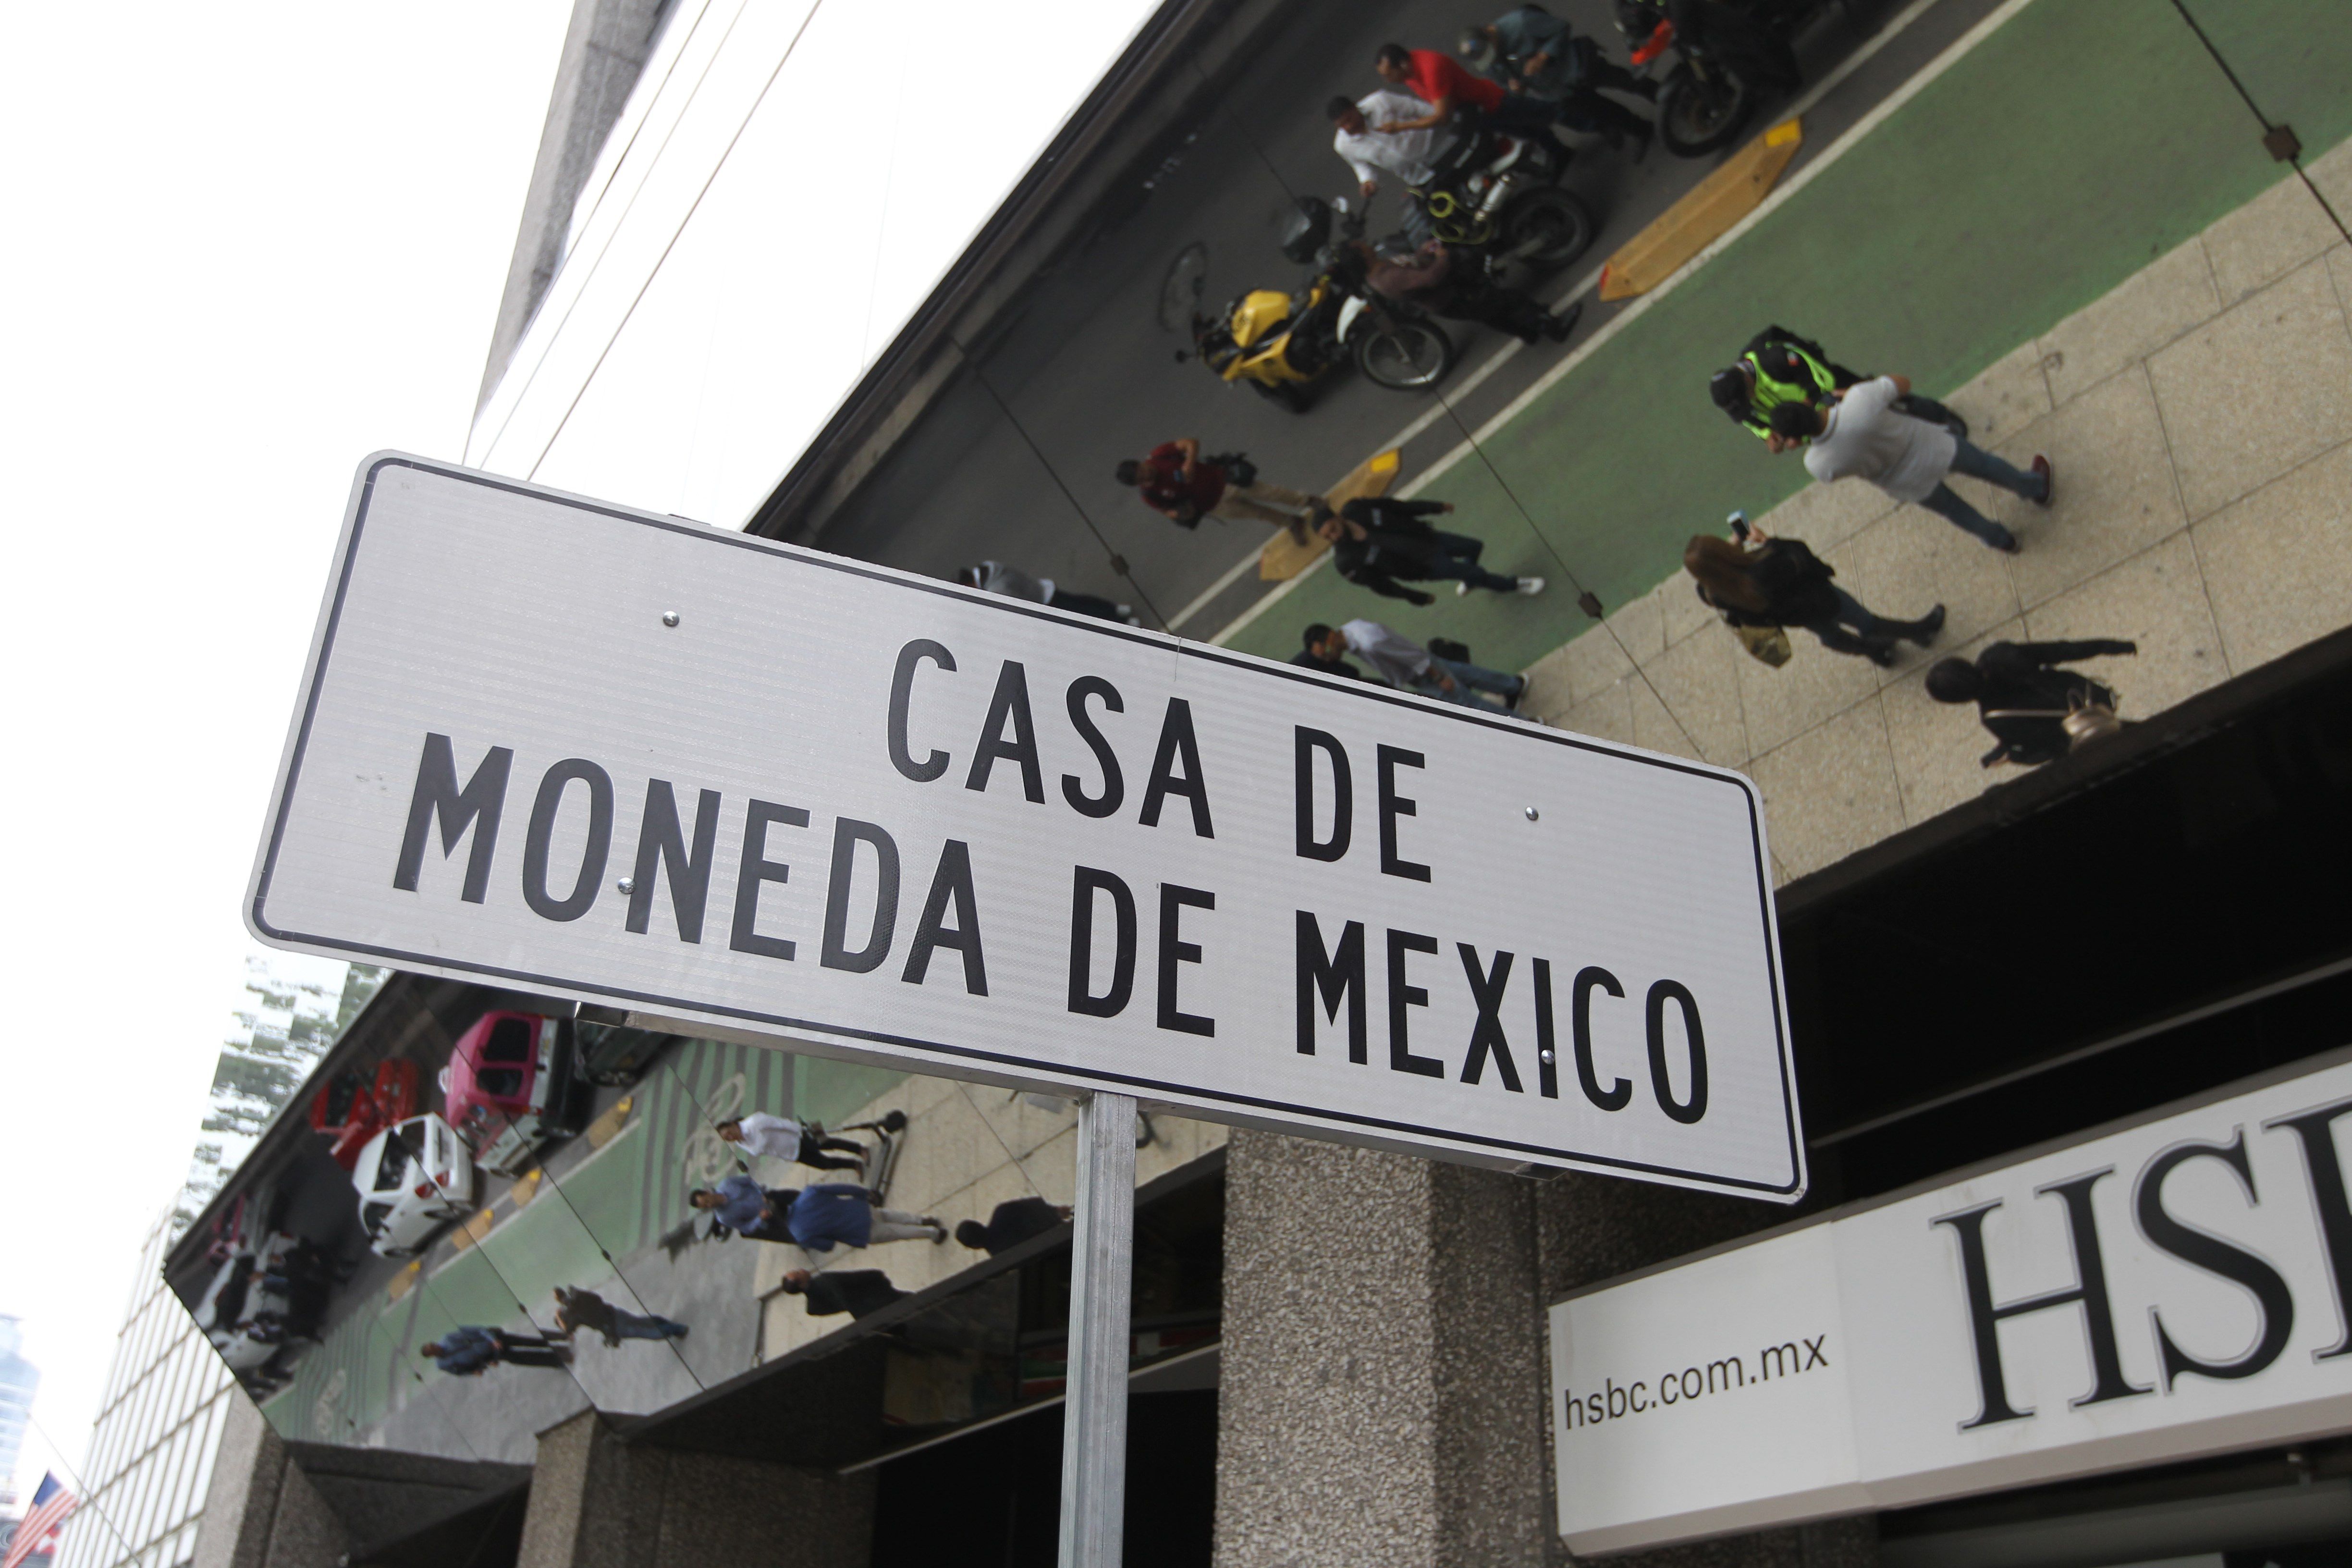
xmin=1216 ymin=1131 xmax=1548 ymax=1568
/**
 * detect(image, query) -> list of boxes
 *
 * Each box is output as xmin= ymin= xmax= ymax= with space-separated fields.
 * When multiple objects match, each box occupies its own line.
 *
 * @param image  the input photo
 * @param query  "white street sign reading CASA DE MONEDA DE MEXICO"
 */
xmin=247 ymin=456 xmax=1804 ymax=1199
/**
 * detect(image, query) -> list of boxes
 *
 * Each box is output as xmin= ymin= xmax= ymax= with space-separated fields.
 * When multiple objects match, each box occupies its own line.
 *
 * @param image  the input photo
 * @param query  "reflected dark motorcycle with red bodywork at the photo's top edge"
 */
xmin=1618 ymin=0 xmax=1865 ymax=158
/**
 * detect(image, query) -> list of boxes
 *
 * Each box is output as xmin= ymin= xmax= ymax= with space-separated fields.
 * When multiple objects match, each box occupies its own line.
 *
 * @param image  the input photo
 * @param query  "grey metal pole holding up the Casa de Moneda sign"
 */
xmin=1061 ymin=1093 xmax=1136 ymax=1568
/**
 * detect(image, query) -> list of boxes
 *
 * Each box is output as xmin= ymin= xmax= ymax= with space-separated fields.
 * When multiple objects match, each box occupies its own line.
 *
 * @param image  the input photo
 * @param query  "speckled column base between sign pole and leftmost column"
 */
xmin=515 ymin=1410 xmax=875 ymax=1568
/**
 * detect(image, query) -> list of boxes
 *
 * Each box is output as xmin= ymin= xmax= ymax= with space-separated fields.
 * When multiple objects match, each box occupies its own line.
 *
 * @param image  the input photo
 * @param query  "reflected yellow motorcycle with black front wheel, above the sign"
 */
xmin=1195 ymin=195 xmax=1454 ymax=414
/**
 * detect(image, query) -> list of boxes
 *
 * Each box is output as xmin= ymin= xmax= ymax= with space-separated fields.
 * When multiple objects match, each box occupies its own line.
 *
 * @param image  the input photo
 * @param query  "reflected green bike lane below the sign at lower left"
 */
xmin=261 ymin=1039 xmax=903 ymax=1458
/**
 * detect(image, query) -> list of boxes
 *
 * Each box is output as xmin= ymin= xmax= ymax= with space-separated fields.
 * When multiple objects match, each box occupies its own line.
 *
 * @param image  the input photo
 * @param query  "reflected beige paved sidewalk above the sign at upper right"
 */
xmin=1527 ymin=146 xmax=2352 ymax=879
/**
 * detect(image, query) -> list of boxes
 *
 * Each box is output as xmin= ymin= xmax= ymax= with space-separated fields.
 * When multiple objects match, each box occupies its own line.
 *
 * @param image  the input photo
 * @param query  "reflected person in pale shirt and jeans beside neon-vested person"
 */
xmin=1769 ymin=376 xmax=2051 ymax=555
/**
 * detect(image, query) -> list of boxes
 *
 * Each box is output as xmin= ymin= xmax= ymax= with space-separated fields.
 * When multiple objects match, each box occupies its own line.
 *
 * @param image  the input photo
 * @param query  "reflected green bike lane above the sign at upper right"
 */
xmin=1230 ymin=0 xmax=2352 ymax=670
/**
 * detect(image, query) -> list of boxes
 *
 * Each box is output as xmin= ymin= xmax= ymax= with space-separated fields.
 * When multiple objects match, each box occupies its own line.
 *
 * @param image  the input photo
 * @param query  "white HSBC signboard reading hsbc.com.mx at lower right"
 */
xmin=1552 ymin=1058 xmax=2352 ymax=1554
